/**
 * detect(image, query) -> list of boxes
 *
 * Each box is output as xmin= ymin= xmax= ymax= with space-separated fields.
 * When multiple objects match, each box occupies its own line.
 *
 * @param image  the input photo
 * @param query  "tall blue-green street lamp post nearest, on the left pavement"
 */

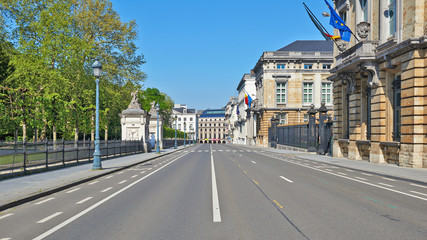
xmin=92 ymin=58 xmax=102 ymax=170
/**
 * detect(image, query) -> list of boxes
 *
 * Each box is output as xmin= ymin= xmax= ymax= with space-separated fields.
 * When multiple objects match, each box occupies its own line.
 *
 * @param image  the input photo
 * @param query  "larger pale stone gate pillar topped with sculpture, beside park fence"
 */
xmin=119 ymin=91 xmax=151 ymax=152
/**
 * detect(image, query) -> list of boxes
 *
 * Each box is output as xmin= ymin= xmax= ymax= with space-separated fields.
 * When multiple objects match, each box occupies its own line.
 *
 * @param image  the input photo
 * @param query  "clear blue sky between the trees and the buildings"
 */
xmin=111 ymin=0 xmax=332 ymax=110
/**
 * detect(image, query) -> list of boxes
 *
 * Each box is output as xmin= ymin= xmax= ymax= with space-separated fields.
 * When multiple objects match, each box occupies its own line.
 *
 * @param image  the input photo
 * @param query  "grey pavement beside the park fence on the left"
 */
xmin=0 ymin=146 xmax=189 ymax=211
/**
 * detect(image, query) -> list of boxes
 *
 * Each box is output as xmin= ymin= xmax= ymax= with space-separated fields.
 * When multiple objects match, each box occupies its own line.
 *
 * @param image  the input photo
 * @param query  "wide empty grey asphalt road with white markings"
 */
xmin=0 ymin=144 xmax=427 ymax=240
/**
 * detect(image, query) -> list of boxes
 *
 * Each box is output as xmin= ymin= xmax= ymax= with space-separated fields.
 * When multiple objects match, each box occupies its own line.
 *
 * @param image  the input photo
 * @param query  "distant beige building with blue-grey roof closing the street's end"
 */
xmin=198 ymin=109 xmax=227 ymax=143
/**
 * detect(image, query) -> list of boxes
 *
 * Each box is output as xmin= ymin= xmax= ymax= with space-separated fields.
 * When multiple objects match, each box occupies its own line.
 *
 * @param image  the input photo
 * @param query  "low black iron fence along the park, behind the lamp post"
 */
xmin=0 ymin=140 xmax=144 ymax=175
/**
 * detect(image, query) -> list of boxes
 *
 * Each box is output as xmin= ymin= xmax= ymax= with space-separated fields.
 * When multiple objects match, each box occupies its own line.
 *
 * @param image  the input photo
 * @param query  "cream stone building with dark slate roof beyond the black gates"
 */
xmin=252 ymin=40 xmax=333 ymax=147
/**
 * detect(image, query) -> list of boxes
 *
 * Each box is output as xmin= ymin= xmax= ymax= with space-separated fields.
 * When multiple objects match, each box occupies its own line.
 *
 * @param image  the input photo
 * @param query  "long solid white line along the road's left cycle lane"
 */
xmin=33 ymin=154 xmax=185 ymax=240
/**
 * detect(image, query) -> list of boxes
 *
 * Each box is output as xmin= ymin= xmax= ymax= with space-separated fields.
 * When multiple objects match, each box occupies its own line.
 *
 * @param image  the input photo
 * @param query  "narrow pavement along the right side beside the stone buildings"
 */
xmin=263 ymin=148 xmax=427 ymax=184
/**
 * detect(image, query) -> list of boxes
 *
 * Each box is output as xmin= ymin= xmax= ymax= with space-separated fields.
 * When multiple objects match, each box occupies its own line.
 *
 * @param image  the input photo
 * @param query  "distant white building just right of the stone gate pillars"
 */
xmin=171 ymin=104 xmax=197 ymax=140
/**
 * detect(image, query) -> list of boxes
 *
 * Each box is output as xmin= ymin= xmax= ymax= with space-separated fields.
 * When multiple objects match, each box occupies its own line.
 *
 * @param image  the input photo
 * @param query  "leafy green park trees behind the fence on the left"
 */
xmin=0 ymin=0 xmax=173 ymax=141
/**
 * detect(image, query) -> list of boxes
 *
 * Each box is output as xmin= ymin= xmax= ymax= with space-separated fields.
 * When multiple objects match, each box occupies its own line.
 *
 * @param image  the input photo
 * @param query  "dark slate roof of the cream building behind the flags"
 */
xmin=277 ymin=40 xmax=334 ymax=52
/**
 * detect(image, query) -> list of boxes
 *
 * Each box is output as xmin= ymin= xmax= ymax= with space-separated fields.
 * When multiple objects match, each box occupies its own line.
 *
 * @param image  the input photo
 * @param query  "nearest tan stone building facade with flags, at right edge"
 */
xmin=328 ymin=0 xmax=427 ymax=168
